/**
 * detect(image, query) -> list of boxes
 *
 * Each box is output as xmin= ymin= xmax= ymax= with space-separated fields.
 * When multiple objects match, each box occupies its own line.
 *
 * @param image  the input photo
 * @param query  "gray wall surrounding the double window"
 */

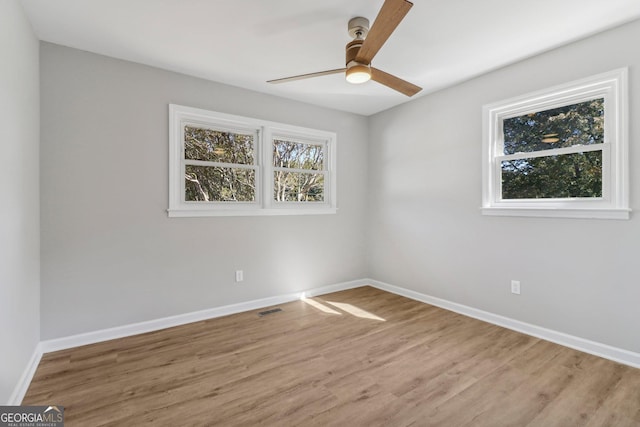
xmin=40 ymin=43 xmax=368 ymax=339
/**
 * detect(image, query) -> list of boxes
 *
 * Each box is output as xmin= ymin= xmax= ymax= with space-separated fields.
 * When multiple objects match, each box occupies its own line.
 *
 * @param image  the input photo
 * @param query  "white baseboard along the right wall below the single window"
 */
xmin=367 ymin=280 xmax=640 ymax=368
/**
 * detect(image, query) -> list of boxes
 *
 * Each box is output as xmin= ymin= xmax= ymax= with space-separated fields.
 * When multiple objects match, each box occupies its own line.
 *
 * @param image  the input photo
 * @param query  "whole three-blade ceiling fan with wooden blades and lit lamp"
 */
xmin=267 ymin=0 xmax=422 ymax=96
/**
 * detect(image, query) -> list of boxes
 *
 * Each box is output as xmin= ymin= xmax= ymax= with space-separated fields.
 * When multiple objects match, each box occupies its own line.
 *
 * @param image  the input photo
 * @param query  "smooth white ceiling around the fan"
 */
xmin=22 ymin=0 xmax=640 ymax=115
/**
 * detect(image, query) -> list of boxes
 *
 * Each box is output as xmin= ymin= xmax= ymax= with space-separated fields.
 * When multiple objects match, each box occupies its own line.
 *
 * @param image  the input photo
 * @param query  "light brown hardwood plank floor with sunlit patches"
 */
xmin=23 ymin=287 xmax=640 ymax=427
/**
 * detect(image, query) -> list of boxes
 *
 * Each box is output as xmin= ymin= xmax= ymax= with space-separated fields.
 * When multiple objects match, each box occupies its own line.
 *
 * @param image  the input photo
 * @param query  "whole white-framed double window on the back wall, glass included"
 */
xmin=168 ymin=105 xmax=336 ymax=216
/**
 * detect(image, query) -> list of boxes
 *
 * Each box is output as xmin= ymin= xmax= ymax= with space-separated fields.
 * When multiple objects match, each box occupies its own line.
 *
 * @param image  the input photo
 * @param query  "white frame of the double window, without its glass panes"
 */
xmin=167 ymin=104 xmax=337 ymax=217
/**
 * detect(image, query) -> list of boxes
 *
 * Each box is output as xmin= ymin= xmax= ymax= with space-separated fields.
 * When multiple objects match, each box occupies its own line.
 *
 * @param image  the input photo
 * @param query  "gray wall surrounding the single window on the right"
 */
xmin=368 ymin=21 xmax=640 ymax=352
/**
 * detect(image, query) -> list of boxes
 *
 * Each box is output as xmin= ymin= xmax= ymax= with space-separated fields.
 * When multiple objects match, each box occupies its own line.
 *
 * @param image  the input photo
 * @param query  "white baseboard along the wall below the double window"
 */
xmin=40 ymin=280 xmax=368 ymax=353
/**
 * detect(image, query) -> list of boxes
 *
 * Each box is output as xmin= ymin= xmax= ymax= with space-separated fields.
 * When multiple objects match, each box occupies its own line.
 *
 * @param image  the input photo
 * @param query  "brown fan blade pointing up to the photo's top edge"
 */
xmin=356 ymin=0 xmax=413 ymax=65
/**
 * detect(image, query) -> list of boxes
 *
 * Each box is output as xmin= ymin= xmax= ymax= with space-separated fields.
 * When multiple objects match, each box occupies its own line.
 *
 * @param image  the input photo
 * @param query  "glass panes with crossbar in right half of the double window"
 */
xmin=272 ymin=137 xmax=327 ymax=203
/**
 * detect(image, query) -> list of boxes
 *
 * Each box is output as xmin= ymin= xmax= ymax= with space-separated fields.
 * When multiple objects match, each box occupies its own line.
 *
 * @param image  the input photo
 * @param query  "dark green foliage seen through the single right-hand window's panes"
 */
xmin=501 ymin=98 xmax=604 ymax=199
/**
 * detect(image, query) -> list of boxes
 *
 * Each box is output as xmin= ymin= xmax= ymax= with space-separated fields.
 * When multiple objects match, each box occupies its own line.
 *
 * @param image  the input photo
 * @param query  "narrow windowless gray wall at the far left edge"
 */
xmin=0 ymin=0 xmax=40 ymax=404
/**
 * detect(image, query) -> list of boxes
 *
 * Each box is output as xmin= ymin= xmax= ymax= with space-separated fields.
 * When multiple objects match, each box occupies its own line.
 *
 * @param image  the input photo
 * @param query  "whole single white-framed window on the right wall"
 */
xmin=482 ymin=69 xmax=630 ymax=219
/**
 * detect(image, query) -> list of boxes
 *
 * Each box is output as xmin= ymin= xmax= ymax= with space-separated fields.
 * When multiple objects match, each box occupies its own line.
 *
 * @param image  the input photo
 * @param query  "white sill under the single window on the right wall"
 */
xmin=481 ymin=207 xmax=631 ymax=219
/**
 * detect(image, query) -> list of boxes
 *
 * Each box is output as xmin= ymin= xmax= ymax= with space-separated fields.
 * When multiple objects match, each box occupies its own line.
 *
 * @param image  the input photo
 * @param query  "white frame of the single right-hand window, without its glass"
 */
xmin=482 ymin=68 xmax=631 ymax=219
